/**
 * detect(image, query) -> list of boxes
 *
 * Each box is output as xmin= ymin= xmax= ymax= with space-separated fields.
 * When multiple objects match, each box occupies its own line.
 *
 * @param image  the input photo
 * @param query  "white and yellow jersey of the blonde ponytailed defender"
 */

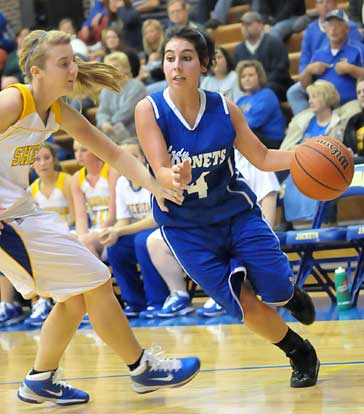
xmin=0 ymin=84 xmax=61 ymax=220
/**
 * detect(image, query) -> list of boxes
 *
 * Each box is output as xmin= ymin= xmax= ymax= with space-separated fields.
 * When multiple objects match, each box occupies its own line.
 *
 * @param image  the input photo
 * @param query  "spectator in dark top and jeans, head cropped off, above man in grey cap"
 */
xmin=257 ymin=0 xmax=306 ymax=41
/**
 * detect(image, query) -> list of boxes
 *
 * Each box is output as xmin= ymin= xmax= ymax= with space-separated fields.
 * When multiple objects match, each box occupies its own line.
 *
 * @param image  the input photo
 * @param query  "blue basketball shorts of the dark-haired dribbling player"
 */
xmin=161 ymin=206 xmax=293 ymax=319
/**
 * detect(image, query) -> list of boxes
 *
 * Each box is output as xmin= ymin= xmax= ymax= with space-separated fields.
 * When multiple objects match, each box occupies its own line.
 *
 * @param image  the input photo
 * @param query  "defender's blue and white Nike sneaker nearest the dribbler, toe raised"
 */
xmin=130 ymin=347 xmax=200 ymax=394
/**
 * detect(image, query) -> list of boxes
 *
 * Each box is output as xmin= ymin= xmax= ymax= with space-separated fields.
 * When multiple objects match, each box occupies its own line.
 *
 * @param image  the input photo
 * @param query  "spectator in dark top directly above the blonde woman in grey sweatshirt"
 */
xmin=102 ymin=24 xmax=140 ymax=78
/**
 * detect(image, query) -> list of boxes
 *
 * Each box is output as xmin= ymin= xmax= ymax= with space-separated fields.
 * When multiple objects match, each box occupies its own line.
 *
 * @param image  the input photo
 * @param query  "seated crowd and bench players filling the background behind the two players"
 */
xmin=0 ymin=0 xmax=364 ymax=326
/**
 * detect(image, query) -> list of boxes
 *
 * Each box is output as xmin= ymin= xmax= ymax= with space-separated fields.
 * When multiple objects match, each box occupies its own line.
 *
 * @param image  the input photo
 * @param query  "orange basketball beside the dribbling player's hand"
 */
xmin=290 ymin=136 xmax=354 ymax=201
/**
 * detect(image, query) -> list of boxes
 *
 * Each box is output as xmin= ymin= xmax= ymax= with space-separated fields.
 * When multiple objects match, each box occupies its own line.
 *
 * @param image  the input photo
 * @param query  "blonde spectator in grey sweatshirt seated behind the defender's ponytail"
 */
xmin=96 ymin=52 xmax=146 ymax=144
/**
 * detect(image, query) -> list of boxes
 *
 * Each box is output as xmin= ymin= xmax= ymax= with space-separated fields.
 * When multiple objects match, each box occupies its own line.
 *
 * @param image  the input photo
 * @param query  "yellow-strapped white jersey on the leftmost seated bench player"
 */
xmin=30 ymin=171 xmax=71 ymax=223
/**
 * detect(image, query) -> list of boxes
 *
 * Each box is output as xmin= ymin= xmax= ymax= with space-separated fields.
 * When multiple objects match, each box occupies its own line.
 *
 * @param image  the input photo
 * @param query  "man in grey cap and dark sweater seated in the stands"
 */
xmin=232 ymin=11 xmax=292 ymax=101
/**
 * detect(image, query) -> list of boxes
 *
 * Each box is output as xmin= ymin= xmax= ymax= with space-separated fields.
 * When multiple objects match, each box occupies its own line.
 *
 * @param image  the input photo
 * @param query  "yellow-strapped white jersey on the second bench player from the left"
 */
xmin=79 ymin=163 xmax=110 ymax=228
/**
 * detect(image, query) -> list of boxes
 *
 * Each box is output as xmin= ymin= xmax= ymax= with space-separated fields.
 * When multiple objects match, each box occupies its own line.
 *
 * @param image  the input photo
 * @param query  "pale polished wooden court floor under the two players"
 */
xmin=0 ymin=320 xmax=364 ymax=414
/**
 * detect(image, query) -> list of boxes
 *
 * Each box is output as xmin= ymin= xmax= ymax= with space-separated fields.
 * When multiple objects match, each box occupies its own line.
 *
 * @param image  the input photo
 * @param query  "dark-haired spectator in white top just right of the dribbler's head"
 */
xmin=200 ymin=47 xmax=242 ymax=101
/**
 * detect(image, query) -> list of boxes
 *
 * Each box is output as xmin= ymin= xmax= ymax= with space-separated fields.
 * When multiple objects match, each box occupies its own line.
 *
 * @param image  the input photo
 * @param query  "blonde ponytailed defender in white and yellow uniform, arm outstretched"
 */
xmin=0 ymin=30 xmax=200 ymax=405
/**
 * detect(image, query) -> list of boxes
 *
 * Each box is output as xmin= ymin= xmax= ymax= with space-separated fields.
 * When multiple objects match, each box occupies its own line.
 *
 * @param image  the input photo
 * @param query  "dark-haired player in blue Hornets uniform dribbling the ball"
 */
xmin=136 ymin=27 xmax=319 ymax=388
